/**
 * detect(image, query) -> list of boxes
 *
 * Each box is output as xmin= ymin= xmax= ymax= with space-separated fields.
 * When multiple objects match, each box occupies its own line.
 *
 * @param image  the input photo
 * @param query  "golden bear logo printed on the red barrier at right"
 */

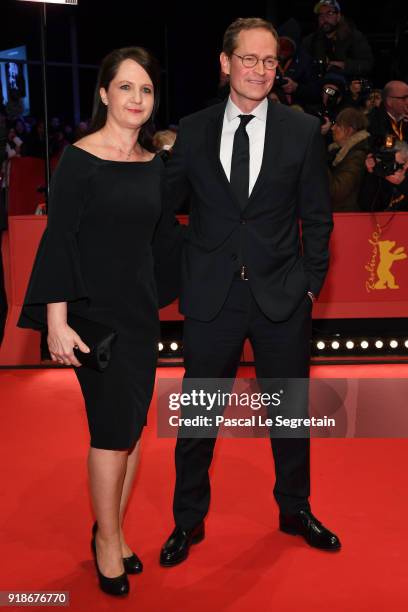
xmin=365 ymin=232 xmax=408 ymax=291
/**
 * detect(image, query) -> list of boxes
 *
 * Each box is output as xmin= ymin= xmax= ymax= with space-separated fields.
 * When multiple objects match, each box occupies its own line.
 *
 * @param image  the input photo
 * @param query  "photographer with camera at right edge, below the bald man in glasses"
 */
xmin=359 ymin=140 xmax=408 ymax=212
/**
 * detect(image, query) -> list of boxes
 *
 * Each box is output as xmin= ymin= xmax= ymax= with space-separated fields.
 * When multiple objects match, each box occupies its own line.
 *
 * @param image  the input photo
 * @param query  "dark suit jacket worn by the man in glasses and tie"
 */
xmin=167 ymin=103 xmax=332 ymax=321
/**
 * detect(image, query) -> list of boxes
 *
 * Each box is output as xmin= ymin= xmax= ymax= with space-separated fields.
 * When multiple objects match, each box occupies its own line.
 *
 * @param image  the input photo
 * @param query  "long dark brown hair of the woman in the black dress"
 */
xmin=89 ymin=47 xmax=160 ymax=152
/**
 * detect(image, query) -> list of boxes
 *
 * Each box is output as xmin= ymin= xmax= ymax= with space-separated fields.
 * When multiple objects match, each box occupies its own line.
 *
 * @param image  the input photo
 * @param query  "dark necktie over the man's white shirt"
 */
xmin=230 ymin=115 xmax=254 ymax=210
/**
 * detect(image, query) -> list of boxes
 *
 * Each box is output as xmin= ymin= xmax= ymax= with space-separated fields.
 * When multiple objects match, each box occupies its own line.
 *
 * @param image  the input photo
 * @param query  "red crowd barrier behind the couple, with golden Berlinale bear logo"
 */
xmin=0 ymin=213 xmax=408 ymax=365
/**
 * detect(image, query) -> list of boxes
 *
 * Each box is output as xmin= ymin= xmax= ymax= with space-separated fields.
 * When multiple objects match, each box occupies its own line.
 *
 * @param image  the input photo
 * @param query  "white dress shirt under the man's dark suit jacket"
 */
xmin=220 ymin=98 xmax=268 ymax=195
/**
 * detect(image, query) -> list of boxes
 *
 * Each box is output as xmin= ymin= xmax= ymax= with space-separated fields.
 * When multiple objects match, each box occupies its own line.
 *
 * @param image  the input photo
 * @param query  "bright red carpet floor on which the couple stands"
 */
xmin=0 ymin=365 xmax=408 ymax=612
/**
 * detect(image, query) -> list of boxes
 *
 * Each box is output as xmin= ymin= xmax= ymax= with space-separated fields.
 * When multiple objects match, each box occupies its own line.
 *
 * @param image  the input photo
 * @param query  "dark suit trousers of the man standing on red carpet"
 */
xmin=173 ymin=278 xmax=312 ymax=529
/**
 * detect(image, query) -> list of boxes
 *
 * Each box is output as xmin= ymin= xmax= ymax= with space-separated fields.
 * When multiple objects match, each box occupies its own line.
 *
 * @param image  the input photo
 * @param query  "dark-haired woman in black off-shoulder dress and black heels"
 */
xmin=19 ymin=47 xmax=180 ymax=595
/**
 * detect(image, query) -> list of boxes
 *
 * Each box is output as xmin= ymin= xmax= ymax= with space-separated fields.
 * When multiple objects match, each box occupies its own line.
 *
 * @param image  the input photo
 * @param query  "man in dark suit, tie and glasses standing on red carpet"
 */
xmin=160 ymin=18 xmax=340 ymax=566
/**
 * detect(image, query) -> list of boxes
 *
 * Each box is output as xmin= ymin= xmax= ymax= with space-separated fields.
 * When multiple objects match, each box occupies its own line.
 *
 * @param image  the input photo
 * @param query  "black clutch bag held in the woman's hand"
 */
xmin=67 ymin=314 xmax=117 ymax=372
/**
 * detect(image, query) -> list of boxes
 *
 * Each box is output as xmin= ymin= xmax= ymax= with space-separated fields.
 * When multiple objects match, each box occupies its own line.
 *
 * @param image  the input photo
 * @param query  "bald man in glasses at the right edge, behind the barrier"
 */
xmin=368 ymin=81 xmax=408 ymax=143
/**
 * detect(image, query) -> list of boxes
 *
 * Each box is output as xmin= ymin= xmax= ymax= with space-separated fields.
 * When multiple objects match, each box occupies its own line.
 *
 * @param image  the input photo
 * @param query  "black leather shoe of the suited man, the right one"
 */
xmin=279 ymin=510 xmax=341 ymax=551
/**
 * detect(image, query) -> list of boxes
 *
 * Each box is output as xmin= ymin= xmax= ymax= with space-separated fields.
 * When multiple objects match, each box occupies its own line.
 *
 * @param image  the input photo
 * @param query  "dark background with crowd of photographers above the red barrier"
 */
xmin=0 ymin=0 xmax=408 ymax=344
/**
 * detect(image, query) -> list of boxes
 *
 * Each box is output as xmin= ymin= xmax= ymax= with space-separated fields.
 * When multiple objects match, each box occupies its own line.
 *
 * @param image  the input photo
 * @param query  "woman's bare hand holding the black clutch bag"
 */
xmin=47 ymin=302 xmax=89 ymax=368
